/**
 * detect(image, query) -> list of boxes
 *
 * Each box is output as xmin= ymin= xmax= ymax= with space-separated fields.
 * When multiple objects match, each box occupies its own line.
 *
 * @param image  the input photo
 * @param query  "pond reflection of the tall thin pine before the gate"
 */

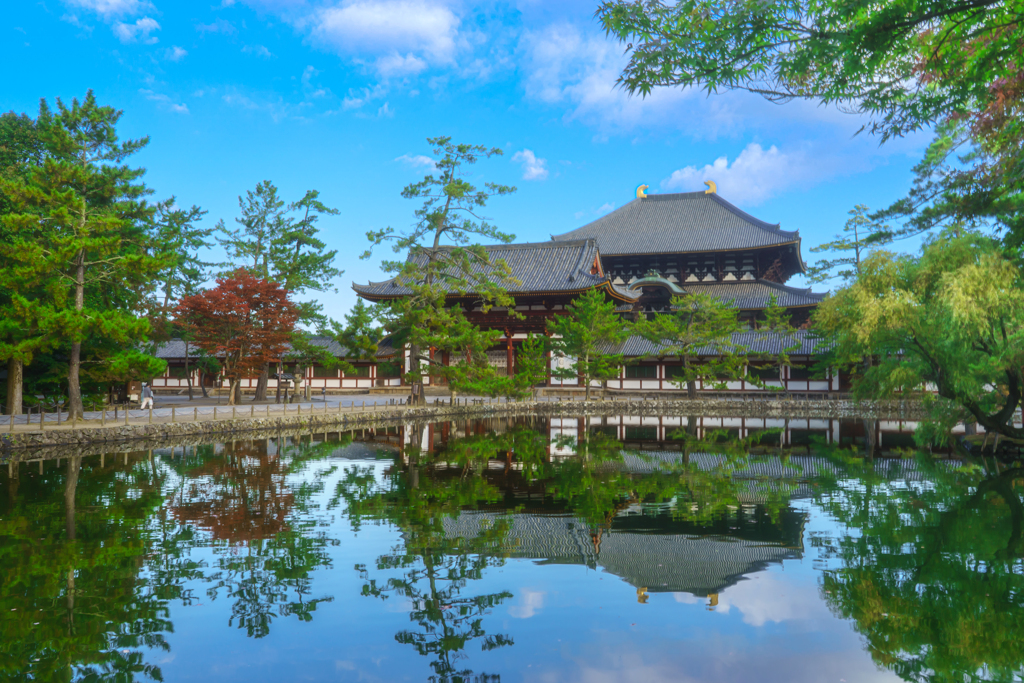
xmin=337 ymin=427 xmax=513 ymax=683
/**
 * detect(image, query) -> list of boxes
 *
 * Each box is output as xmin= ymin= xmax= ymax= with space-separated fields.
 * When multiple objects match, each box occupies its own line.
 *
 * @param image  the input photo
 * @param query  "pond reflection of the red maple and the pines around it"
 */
xmin=163 ymin=437 xmax=347 ymax=638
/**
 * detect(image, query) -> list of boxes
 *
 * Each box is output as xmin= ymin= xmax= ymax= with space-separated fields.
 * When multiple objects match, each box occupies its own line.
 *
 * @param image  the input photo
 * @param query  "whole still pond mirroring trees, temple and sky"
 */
xmin=0 ymin=418 xmax=1024 ymax=683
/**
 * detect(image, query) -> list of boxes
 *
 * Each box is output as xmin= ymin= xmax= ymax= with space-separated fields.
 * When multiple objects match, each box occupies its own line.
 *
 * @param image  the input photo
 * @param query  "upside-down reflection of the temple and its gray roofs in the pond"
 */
xmin=380 ymin=416 xmax=954 ymax=602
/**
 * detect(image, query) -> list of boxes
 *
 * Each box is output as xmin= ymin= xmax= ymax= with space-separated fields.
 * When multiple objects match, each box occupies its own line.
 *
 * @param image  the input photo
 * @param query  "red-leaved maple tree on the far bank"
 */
xmin=175 ymin=268 xmax=299 ymax=405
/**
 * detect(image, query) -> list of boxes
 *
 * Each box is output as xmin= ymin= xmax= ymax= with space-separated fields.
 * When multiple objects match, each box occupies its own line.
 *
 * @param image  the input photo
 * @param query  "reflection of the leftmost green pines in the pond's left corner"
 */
xmin=0 ymin=450 xmax=171 ymax=681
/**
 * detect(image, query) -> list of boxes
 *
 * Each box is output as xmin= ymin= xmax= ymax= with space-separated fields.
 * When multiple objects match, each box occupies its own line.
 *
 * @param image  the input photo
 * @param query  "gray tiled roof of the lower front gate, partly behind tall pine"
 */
xmin=352 ymin=240 xmax=640 ymax=300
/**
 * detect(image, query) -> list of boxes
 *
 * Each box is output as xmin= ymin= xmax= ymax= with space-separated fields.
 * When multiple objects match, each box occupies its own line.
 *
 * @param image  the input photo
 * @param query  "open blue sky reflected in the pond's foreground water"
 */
xmin=136 ymin=448 xmax=898 ymax=683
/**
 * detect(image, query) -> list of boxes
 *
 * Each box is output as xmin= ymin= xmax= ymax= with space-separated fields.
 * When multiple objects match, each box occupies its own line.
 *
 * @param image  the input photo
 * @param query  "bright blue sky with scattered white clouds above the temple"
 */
xmin=0 ymin=0 xmax=925 ymax=317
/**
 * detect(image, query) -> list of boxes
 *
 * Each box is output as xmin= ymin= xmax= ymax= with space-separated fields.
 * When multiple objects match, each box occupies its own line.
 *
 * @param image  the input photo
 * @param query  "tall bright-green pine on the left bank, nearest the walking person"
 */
xmin=0 ymin=91 xmax=167 ymax=418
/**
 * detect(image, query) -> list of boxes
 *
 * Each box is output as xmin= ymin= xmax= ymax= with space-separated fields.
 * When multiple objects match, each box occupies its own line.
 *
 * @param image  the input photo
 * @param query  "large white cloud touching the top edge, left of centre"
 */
xmin=304 ymin=0 xmax=459 ymax=73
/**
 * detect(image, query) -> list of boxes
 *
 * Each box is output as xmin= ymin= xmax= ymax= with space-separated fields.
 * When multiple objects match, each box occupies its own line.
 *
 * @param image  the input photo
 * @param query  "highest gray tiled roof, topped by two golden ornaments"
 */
xmin=552 ymin=193 xmax=800 ymax=256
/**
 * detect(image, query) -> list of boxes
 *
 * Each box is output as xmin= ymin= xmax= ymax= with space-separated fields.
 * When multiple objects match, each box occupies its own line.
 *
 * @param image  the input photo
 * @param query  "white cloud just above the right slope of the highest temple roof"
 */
xmin=662 ymin=142 xmax=823 ymax=205
